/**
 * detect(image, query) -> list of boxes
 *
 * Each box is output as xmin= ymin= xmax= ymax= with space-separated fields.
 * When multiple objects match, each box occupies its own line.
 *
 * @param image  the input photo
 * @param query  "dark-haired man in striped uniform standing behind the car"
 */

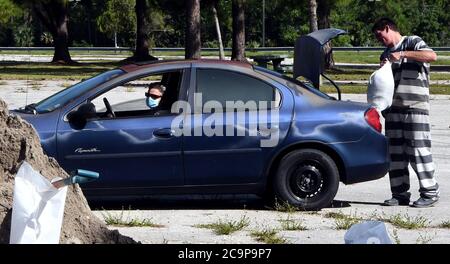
xmin=372 ymin=18 xmax=439 ymax=207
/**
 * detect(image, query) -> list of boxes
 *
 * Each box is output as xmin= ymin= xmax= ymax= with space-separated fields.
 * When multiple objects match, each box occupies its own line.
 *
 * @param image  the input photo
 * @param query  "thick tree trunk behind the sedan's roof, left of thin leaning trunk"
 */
xmin=185 ymin=0 xmax=201 ymax=59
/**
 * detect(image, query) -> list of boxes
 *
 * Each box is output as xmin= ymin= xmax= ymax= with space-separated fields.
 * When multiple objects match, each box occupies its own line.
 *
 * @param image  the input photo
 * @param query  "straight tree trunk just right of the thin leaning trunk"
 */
xmin=231 ymin=0 xmax=247 ymax=61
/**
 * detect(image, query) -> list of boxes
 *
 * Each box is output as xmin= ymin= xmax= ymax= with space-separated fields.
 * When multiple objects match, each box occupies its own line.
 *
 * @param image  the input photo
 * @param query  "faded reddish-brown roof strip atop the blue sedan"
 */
xmin=120 ymin=59 xmax=253 ymax=72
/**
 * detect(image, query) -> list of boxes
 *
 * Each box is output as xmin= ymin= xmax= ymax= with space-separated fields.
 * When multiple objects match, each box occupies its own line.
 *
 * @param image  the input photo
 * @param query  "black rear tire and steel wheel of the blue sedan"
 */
xmin=273 ymin=149 xmax=339 ymax=210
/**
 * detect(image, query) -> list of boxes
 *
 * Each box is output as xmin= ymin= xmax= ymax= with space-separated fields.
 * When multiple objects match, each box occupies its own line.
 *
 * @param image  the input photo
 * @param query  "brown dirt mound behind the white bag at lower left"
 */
xmin=0 ymin=99 xmax=136 ymax=244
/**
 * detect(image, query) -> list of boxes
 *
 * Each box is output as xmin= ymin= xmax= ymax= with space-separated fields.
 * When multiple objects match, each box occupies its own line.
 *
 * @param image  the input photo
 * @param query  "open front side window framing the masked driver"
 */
xmin=91 ymin=71 xmax=182 ymax=118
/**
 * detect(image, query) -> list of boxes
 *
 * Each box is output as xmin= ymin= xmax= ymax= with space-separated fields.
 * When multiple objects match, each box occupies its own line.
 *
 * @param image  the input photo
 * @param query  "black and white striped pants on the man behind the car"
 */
xmin=386 ymin=111 xmax=439 ymax=197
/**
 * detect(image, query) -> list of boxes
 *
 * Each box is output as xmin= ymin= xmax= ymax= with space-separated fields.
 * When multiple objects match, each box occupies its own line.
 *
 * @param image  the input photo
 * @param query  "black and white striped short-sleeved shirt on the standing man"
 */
xmin=380 ymin=36 xmax=432 ymax=113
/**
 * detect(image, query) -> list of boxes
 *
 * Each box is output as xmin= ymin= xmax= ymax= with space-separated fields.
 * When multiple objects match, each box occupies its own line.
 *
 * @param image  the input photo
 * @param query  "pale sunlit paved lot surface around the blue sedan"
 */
xmin=0 ymin=81 xmax=450 ymax=243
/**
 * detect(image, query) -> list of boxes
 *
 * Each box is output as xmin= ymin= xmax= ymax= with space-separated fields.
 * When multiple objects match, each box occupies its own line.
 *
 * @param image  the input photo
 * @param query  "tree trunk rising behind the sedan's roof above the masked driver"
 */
xmin=131 ymin=0 xmax=158 ymax=61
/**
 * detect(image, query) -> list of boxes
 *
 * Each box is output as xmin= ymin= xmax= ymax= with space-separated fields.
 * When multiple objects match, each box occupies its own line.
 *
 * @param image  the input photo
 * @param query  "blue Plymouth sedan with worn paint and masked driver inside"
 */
xmin=15 ymin=60 xmax=389 ymax=210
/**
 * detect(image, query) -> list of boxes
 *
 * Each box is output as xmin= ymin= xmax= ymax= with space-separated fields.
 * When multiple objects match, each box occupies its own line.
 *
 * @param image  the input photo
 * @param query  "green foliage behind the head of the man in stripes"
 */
xmin=331 ymin=0 xmax=450 ymax=46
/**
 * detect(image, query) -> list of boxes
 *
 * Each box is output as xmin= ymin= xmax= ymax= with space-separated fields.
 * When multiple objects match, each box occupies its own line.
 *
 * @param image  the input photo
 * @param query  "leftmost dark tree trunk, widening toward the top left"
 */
xmin=33 ymin=0 xmax=73 ymax=63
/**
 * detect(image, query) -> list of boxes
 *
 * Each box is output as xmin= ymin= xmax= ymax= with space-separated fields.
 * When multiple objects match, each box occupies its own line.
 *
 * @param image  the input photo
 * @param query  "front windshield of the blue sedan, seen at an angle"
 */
xmin=30 ymin=69 xmax=125 ymax=113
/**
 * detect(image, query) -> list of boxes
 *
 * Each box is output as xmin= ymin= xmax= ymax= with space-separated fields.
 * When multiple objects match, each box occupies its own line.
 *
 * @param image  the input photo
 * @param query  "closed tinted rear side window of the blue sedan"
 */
xmin=194 ymin=69 xmax=281 ymax=111
